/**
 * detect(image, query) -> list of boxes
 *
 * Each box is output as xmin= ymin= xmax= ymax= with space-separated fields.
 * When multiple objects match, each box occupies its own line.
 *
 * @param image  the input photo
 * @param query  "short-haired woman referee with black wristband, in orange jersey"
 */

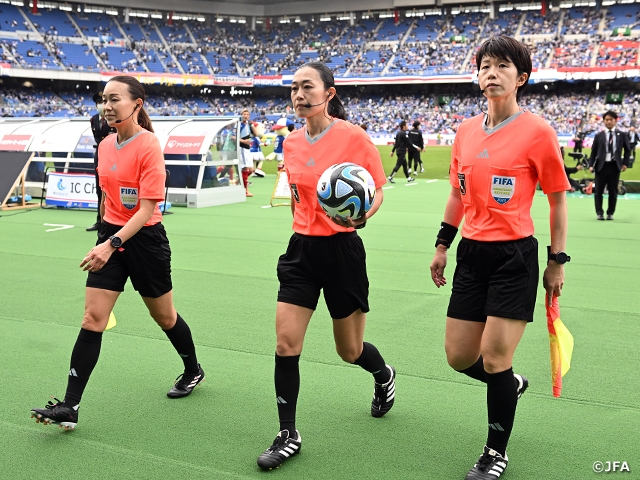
xmin=431 ymin=36 xmax=569 ymax=480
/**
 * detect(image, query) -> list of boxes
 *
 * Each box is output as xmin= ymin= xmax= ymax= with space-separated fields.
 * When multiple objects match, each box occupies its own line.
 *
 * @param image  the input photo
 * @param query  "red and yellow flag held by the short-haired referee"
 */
xmin=545 ymin=295 xmax=573 ymax=398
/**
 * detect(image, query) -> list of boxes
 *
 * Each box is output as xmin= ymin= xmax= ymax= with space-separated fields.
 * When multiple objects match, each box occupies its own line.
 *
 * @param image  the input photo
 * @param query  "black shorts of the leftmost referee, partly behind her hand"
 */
xmin=87 ymin=222 xmax=173 ymax=298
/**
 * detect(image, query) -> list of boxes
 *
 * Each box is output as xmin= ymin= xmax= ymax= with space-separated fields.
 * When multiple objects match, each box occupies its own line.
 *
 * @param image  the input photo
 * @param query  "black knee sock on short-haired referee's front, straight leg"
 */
xmin=485 ymin=368 xmax=518 ymax=456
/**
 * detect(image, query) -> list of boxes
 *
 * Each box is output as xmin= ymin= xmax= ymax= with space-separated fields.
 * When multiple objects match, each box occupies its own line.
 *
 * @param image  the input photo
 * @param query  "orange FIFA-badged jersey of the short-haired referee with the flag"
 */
xmin=449 ymin=111 xmax=570 ymax=242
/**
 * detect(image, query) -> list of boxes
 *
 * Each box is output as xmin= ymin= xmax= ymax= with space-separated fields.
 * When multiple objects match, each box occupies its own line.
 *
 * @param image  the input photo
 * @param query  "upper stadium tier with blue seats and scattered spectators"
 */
xmin=0 ymin=0 xmax=640 ymax=77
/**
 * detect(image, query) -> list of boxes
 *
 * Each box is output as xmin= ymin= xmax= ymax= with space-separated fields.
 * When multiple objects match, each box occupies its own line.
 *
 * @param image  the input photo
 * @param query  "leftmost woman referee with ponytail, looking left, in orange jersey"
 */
xmin=31 ymin=76 xmax=204 ymax=429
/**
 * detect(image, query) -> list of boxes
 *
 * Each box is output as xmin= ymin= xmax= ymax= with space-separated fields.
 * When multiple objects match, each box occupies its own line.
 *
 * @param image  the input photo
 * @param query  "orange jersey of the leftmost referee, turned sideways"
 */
xmin=98 ymin=130 xmax=166 ymax=226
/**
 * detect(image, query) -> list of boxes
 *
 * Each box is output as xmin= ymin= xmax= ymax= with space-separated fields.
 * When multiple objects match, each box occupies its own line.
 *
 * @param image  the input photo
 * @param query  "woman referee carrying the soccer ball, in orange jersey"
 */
xmin=258 ymin=62 xmax=395 ymax=470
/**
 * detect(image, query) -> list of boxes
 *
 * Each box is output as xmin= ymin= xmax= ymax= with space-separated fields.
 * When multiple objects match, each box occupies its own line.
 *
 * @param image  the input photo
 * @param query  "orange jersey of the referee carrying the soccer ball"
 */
xmin=284 ymin=120 xmax=387 ymax=236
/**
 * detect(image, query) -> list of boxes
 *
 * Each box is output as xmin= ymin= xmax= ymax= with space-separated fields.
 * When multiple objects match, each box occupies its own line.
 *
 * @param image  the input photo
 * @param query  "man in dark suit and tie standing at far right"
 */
xmin=589 ymin=110 xmax=631 ymax=220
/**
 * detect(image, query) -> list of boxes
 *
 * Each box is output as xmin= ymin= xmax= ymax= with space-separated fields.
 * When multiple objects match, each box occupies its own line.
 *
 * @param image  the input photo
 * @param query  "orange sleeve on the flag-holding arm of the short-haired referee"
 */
xmin=529 ymin=119 xmax=571 ymax=194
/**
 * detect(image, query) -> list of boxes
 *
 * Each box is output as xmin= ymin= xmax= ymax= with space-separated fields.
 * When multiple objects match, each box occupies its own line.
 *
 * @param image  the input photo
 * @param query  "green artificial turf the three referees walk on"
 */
xmin=0 ymin=160 xmax=640 ymax=480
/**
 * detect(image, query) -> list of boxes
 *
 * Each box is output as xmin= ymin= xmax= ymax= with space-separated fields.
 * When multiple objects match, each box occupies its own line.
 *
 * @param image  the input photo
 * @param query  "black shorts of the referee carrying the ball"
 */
xmin=278 ymin=232 xmax=369 ymax=319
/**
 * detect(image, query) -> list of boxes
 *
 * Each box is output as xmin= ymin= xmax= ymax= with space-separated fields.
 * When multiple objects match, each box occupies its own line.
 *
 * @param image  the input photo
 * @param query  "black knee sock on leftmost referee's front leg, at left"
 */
xmin=64 ymin=328 xmax=102 ymax=410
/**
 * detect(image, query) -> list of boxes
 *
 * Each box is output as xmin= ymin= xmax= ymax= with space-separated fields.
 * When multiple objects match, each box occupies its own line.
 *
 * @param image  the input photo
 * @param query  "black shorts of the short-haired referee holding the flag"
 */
xmin=447 ymin=237 xmax=539 ymax=322
